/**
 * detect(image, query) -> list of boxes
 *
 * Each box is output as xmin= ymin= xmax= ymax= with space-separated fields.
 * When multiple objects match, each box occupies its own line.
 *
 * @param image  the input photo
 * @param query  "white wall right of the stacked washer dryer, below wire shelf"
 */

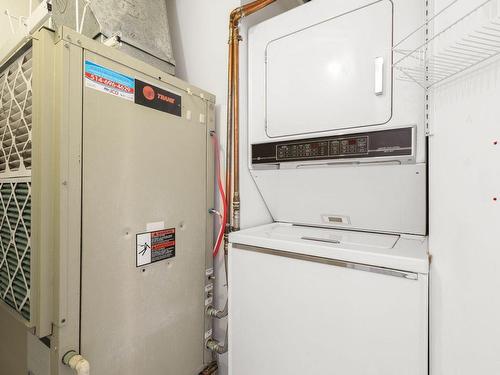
xmin=429 ymin=0 xmax=500 ymax=375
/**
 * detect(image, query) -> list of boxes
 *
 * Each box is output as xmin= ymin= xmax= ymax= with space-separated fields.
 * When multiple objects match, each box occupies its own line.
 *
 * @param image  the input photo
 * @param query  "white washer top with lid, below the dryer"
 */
xmin=229 ymin=223 xmax=429 ymax=274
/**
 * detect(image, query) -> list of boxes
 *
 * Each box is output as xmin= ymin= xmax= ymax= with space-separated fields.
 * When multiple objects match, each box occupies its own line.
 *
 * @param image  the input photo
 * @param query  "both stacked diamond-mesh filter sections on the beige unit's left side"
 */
xmin=0 ymin=48 xmax=32 ymax=322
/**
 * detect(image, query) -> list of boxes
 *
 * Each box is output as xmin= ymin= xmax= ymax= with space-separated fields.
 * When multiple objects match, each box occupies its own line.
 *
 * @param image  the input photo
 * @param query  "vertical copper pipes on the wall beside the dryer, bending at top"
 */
xmin=224 ymin=0 xmax=276 ymax=235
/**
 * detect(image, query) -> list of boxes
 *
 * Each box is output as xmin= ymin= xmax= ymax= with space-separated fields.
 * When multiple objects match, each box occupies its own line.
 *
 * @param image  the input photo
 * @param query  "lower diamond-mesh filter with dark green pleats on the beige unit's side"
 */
xmin=0 ymin=182 xmax=31 ymax=321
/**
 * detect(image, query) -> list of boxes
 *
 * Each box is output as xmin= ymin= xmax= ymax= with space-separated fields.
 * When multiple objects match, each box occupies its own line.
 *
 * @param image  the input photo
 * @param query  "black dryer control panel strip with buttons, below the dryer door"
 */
xmin=252 ymin=127 xmax=414 ymax=164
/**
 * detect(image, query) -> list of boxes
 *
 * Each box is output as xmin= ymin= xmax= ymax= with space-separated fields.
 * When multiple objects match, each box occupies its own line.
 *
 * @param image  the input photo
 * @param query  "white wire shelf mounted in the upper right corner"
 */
xmin=393 ymin=0 xmax=500 ymax=89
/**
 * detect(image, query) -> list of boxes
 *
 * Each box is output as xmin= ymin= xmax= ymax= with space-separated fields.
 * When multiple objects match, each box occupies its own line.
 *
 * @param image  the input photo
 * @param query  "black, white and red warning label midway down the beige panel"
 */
xmin=136 ymin=228 xmax=175 ymax=267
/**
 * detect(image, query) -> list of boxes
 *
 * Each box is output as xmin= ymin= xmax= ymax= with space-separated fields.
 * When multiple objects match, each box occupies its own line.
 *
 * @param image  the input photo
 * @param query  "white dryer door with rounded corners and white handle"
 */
xmin=266 ymin=0 xmax=393 ymax=137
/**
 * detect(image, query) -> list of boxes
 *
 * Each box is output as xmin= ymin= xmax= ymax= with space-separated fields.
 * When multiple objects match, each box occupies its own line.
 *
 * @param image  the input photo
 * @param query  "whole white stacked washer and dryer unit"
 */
xmin=229 ymin=0 xmax=429 ymax=375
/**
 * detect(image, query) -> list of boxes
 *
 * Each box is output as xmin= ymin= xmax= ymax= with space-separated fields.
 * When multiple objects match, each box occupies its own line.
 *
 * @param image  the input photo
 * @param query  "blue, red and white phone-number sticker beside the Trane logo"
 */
xmin=85 ymin=60 xmax=135 ymax=101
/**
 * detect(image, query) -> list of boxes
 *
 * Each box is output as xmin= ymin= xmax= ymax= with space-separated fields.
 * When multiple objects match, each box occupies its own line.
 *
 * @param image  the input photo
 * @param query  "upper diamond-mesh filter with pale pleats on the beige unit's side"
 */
xmin=0 ymin=49 xmax=32 ymax=176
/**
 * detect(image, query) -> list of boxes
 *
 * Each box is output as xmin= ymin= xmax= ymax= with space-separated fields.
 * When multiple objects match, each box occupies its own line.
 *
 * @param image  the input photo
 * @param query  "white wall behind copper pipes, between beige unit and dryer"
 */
xmin=166 ymin=0 xmax=300 ymax=375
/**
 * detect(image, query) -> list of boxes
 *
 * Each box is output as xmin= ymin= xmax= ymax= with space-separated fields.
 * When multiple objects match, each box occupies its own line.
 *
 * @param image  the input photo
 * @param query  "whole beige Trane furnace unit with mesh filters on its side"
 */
xmin=0 ymin=27 xmax=215 ymax=375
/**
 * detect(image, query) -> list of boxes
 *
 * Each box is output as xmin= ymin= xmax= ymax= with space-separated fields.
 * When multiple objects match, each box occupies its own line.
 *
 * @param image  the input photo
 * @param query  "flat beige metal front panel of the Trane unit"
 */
xmin=81 ymin=51 xmax=207 ymax=375
